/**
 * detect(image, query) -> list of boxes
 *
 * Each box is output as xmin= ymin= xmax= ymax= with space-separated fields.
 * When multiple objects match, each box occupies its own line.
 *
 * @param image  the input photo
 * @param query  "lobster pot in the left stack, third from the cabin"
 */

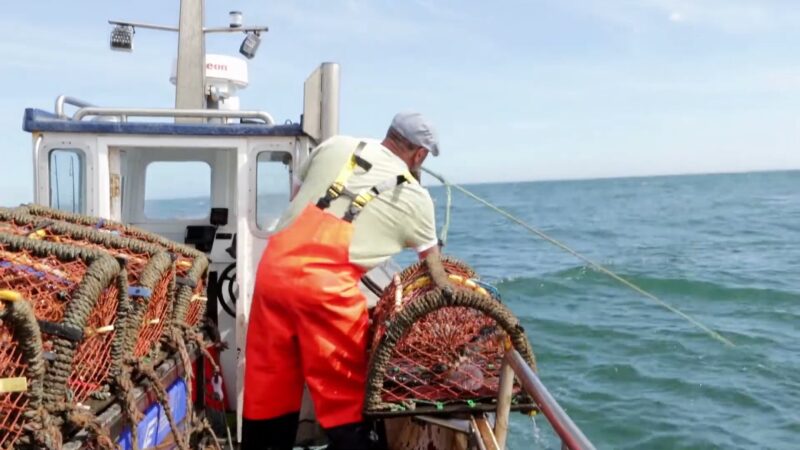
xmin=0 ymin=233 xmax=127 ymax=448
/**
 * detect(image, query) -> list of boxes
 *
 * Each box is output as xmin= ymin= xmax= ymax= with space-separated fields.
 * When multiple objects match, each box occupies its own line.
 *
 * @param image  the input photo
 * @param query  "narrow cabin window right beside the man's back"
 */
xmin=256 ymin=152 xmax=292 ymax=232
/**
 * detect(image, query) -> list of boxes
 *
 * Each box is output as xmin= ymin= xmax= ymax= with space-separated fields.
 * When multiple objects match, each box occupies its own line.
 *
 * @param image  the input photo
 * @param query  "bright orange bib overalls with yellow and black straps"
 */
xmin=243 ymin=142 xmax=413 ymax=428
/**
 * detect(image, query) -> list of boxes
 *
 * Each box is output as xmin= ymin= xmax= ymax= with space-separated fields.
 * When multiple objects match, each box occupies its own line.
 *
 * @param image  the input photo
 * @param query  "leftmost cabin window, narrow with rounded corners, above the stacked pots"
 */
xmin=49 ymin=148 xmax=86 ymax=214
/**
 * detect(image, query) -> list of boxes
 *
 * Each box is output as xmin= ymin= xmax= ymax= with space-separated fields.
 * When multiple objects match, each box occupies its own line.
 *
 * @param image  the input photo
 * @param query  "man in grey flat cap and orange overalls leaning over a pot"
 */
xmin=241 ymin=113 xmax=439 ymax=450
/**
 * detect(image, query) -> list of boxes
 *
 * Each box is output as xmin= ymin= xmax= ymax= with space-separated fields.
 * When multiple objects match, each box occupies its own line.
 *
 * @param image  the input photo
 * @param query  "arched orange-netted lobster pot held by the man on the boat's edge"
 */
xmin=365 ymin=258 xmax=534 ymax=415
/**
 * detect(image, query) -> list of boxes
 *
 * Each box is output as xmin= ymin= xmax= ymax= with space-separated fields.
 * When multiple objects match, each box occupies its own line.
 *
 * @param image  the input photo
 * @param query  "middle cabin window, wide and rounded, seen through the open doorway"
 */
xmin=144 ymin=161 xmax=211 ymax=221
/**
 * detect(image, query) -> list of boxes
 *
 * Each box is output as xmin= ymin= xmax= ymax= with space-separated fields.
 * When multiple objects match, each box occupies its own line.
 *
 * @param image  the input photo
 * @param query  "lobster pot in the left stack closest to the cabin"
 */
xmin=17 ymin=204 xmax=208 ymax=329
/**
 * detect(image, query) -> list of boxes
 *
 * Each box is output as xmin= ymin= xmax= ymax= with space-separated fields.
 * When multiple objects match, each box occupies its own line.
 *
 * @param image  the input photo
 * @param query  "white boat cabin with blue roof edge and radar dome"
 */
xmin=23 ymin=59 xmax=374 ymax=440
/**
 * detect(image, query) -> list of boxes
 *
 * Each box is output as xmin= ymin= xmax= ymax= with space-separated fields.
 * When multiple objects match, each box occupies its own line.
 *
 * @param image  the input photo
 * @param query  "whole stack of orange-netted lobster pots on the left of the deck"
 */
xmin=0 ymin=206 xmax=210 ymax=450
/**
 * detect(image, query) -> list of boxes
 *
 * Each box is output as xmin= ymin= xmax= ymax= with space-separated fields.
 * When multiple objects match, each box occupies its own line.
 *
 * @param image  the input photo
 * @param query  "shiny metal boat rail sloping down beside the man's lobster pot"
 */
xmin=504 ymin=349 xmax=594 ymax=450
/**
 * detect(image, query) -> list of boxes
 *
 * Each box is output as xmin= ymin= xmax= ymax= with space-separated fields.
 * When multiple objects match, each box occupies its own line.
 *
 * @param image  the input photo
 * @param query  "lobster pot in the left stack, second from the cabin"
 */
xmin=0 ymin=208 xmax=175 ymax=357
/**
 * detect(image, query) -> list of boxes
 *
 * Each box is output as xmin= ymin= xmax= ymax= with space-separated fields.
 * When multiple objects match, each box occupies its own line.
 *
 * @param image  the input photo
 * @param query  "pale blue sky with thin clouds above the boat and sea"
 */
xmin=0 ymin=0 xmax=800 ymax=205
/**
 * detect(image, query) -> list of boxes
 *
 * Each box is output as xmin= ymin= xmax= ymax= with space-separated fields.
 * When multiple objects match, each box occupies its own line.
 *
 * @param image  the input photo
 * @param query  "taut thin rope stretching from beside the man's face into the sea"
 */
xmin=422 ymin=167 xmax=736 ymax=347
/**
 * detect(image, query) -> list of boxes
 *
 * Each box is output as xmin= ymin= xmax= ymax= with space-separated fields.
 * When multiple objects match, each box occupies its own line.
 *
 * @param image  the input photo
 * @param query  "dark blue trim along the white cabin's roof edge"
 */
xmin=22 ymin=108 xmax=305 ymax=136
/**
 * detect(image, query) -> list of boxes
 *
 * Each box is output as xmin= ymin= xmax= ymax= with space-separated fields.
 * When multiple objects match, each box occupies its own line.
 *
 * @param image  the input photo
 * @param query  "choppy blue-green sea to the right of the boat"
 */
xmin=422 ymin=172 xmax=800 ymax=449
